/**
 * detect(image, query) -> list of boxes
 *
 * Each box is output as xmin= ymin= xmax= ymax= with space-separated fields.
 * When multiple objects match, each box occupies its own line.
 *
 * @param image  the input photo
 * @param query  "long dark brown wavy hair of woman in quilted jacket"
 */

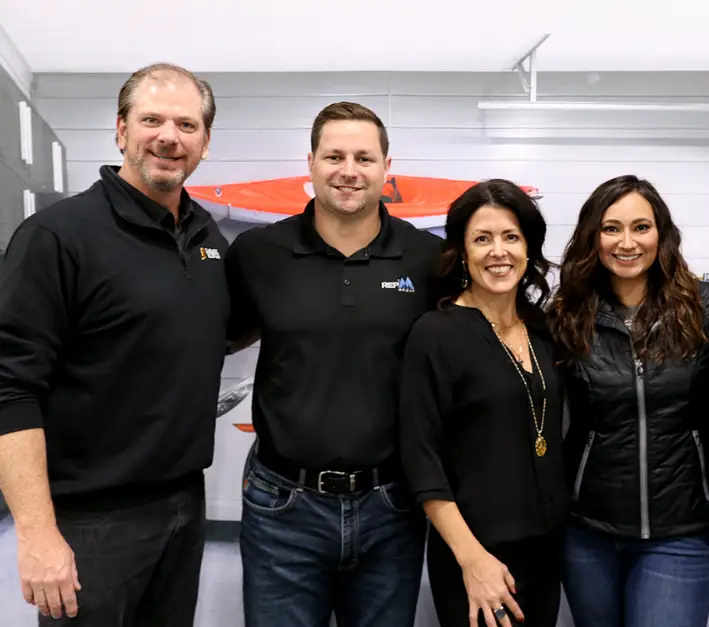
xmin=550 ymin=175 xmax=706 ymax=363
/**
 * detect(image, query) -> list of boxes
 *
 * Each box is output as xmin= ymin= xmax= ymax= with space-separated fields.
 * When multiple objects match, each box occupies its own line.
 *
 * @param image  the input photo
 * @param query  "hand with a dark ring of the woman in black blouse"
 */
xmin=461 ymin=549 xmax=524 ymax=627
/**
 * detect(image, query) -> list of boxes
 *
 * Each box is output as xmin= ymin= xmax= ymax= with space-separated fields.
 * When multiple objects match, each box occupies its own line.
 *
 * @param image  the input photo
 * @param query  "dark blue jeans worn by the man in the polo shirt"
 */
xmin=240 ymin=456 xmax=426 ymax=627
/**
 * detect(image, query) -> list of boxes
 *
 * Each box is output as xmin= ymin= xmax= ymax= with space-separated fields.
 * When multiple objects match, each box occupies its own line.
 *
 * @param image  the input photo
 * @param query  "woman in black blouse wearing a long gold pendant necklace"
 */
xmin=400 ymin=180 xmax=568 ymax=627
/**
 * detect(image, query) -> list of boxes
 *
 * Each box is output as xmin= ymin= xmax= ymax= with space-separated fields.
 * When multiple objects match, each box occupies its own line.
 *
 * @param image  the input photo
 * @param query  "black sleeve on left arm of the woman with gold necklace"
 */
xmin=399 ymin=314 xmax=455 ymax=503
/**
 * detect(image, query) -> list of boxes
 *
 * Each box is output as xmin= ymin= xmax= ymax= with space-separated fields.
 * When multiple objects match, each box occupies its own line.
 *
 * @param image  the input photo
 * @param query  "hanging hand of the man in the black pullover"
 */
xmin=17 ymin=526 xmax=81 ymax=618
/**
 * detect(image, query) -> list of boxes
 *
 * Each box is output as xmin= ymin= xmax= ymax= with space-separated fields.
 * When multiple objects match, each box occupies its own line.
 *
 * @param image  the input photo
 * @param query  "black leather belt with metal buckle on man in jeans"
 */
xmin=256 ymin=450 xmax=403 ymax=494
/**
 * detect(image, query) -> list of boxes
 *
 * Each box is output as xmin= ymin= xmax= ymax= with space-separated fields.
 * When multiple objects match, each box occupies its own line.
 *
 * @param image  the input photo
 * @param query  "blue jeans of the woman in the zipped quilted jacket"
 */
xmin=563 ymin=526 xmax=709 ymax=627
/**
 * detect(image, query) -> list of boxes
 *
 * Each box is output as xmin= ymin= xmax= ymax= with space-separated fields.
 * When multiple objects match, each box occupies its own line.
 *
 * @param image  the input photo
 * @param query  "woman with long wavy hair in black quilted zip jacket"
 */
xmin=550 ymin=176 xmax=709 ymax=627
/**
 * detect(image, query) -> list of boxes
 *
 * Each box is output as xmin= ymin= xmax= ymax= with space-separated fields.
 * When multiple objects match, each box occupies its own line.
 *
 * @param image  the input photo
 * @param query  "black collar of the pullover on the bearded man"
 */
xmin=99 ymin=165 xmax=195 ymax=230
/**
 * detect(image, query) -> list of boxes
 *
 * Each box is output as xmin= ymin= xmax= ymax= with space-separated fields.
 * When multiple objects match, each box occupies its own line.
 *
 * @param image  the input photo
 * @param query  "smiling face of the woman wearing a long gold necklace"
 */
xmin=465 ymin=205 xmax=527 ymax=298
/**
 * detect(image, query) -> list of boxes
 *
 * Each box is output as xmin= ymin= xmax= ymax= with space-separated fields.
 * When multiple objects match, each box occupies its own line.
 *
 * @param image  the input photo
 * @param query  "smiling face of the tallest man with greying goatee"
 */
xmin=117 ymin=74 xmax=209 ymax=194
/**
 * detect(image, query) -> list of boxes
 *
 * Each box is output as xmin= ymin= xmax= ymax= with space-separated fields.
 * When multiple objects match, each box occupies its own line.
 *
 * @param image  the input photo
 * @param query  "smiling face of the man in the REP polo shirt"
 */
xmin=308 ymin=120 xmax=391 ymax=217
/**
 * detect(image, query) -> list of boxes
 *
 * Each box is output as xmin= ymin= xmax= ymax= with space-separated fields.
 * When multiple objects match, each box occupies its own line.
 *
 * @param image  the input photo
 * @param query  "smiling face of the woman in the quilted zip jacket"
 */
xmin=599 ymin=192 xmax=659 ymax=281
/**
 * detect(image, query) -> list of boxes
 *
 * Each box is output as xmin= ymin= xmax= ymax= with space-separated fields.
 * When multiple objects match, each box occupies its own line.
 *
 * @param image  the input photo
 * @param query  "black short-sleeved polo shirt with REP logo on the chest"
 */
xmin=225 ymin=201 xmax=442 ymax=470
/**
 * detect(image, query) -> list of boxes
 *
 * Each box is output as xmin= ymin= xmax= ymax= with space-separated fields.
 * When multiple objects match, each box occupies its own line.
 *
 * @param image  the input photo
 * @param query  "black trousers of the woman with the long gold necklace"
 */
xmin=427 ymin=527 xmax=560 ymax=627
